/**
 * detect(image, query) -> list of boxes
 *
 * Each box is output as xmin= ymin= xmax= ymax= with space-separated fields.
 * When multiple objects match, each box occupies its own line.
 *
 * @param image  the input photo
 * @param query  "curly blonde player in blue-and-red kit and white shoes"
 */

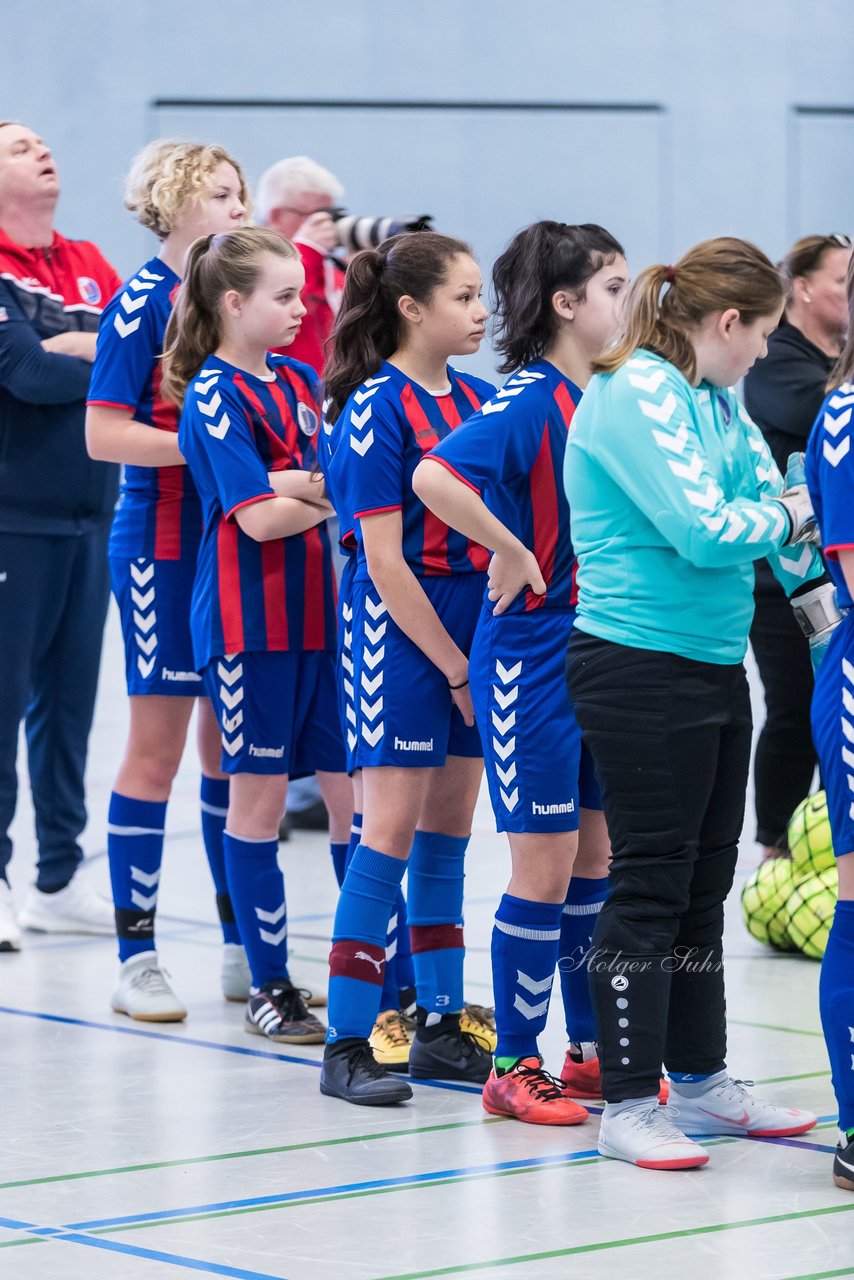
xmin=86 ymin=138 xmax=250 ymax=1021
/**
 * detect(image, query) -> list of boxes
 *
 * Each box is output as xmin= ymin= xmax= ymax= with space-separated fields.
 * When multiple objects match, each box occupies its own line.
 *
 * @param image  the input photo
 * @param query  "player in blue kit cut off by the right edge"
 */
xmin=805 ymin=249 xmax=854 ymax=1192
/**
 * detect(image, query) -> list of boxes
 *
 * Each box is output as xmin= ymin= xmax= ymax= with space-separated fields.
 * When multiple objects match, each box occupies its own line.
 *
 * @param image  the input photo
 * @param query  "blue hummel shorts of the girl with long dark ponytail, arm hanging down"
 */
xmin=341 ymin=573 xmax=487 ymax=772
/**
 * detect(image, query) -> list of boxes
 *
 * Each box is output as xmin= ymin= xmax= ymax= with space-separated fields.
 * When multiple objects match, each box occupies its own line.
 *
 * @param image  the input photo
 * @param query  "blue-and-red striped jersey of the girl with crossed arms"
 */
xmin=178 ymin=355 xmax=335 ymax=671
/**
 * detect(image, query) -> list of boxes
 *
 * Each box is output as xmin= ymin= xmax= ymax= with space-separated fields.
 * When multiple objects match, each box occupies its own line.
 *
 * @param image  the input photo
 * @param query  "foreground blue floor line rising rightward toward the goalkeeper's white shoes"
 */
xmin=64 ymin=1147 xmax=599 ymax=1231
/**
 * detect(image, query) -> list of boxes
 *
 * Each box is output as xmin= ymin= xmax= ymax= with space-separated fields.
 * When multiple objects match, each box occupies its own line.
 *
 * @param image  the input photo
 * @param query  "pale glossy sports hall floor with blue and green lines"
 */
xmin=0 ymin=614 xmax=854 ymax=1280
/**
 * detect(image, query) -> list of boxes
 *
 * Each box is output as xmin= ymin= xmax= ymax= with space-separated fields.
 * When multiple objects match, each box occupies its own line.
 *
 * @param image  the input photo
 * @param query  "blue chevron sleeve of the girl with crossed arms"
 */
xmin=178 ymin=369 xmax=275 ymax=518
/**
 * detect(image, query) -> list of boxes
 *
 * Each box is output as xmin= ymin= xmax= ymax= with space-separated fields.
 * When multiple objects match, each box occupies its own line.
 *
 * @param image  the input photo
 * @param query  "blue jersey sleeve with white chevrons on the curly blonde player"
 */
xmin=87 ymin=291 xmax=163 ymax=412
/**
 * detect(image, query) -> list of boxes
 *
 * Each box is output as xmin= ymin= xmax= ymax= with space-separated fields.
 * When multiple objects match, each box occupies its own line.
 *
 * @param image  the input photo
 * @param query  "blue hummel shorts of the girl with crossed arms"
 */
xmin=205 ymin=650 xmax=346 ymax=778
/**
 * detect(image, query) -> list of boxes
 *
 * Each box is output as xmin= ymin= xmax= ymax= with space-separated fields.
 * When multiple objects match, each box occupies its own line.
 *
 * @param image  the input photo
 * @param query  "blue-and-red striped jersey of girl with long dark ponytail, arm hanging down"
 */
xmin=325 ymin=361 xmax=495 ymax=577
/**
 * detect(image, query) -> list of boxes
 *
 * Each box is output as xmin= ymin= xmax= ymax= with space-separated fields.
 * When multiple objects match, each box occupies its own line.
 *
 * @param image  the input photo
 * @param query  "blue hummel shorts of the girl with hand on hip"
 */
xmin=469 ymin=608 xmax=602 ymax=832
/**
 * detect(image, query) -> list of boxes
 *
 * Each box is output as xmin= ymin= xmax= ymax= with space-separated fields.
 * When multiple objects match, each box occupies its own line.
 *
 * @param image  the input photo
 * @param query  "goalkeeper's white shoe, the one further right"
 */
xmin=665 ymin=1076 xmax=818 ymax=1138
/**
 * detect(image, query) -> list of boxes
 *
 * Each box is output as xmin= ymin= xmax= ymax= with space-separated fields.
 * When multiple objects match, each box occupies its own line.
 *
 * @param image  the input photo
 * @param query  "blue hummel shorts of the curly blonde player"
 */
xmin=110 ymin=556 xmax=204 ymax=698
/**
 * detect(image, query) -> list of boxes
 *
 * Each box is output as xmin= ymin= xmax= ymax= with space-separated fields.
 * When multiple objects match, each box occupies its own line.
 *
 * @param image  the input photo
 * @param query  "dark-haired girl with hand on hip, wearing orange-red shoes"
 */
xmin=414 ymin=221 xmax=627 ymax=1124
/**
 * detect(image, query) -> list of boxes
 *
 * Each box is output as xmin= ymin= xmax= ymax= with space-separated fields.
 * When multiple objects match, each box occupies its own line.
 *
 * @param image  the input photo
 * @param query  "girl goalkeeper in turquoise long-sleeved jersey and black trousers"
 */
xmin=565 ymin=238 xmax=831 ymax=1169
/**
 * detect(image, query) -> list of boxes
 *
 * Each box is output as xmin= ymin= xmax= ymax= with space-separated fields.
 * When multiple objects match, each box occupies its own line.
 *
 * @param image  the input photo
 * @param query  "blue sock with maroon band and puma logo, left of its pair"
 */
xmin=326 ymin=845 xmax=406 ymax=1044
